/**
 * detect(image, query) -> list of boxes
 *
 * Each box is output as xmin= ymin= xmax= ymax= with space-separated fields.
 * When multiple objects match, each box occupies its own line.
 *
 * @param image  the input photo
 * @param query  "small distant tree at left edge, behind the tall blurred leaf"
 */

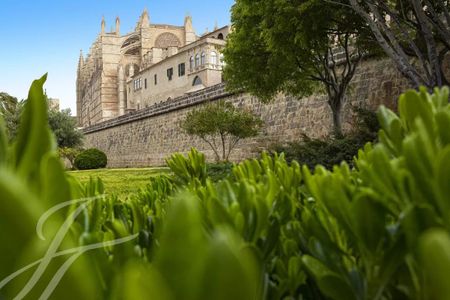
xmin=0 ymin=93 xmax=25 ymax=140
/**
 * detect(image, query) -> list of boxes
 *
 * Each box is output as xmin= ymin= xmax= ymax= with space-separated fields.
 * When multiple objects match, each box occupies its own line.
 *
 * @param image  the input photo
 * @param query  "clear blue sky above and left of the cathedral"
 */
xmin=0 ymin=0 xmax=234 ymax=114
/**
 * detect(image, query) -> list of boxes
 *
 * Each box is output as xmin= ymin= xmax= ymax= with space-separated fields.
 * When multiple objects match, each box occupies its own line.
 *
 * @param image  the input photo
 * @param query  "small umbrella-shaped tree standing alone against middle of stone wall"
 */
xmin=181 ymin=101 xmax=262 ymax=161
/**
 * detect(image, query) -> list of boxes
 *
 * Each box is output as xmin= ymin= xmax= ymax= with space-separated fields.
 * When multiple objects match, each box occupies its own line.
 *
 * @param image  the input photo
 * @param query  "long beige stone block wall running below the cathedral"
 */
xmin=84 ymin=59 xmax=408 ymax=167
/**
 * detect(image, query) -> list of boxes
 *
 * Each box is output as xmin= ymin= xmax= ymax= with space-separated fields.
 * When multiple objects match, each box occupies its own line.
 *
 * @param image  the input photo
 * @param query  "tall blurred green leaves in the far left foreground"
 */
xmin=0 ymin=76 xmax=99 ymax=299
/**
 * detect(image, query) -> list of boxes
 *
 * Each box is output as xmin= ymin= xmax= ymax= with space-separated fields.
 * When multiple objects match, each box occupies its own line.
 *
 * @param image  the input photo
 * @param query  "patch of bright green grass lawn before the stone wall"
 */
xmin=68 ymin=168 xmax=169 ymax=199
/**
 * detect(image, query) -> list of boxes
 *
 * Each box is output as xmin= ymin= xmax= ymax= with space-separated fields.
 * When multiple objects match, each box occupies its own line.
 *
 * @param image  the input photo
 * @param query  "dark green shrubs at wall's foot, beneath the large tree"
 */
xmin=272 ymin=107 xmax=380 ymax=170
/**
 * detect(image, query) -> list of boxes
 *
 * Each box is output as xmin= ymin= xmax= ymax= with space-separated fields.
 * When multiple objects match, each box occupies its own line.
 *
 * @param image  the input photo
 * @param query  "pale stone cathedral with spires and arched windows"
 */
xmin=76 ymin=10 xmax=229 ymax=127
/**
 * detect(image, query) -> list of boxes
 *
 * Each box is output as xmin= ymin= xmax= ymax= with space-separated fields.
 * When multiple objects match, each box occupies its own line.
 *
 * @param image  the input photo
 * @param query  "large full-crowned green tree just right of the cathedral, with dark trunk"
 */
xmin=224 ymin=0 xmax=370 ymax=135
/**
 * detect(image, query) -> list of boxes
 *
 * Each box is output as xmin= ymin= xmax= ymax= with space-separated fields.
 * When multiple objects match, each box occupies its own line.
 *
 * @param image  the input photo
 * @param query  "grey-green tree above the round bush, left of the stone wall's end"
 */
xmin=48 ymin=109 xmax=83 ymax=148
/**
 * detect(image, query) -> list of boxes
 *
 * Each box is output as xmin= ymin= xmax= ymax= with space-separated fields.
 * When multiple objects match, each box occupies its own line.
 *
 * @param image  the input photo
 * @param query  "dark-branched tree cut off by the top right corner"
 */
xmin=349 ymin=0 xmax=450 ymax=90
